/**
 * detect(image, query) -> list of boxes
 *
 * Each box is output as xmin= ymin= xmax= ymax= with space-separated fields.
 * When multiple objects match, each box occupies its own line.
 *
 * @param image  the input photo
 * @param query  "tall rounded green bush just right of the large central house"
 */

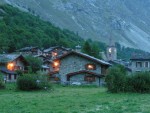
xmin=106 ymin=66 xmax=126 ymax=92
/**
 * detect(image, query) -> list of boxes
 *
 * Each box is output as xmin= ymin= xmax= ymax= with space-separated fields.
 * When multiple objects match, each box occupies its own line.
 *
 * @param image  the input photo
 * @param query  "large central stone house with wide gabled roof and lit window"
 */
xmin=50 ymin=51 xmax=110 ymax=86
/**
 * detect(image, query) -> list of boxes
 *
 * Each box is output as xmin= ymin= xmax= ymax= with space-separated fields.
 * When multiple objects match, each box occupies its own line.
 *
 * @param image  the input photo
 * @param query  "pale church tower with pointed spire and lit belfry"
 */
xmin=106 ymin=38 xmax=117 ymax=61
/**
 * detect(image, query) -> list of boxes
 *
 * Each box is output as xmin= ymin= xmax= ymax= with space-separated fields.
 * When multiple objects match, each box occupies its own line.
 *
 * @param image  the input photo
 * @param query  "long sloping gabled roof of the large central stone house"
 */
xmin=57 ymin=51 xmax=111 ymax=66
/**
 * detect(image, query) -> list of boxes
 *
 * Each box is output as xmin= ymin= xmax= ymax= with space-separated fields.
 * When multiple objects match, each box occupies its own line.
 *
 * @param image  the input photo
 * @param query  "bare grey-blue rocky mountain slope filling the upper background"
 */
xmin=2 ymin=0 xmax=150 ymax=51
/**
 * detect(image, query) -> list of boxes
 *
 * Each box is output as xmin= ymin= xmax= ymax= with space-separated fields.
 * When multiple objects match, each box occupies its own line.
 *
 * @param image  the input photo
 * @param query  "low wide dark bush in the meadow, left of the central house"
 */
xmin=17 ymin=75 xmax=50 ymax=91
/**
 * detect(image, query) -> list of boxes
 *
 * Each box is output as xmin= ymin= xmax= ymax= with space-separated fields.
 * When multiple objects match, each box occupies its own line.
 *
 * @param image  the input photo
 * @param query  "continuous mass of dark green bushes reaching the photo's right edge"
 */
xmin=106 ymin=66 xmax=150 ymax=93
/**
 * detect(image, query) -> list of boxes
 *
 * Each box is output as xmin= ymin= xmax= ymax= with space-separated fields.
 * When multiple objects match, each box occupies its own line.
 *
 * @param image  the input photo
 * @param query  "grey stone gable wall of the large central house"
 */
xmin=59 ymin=55 xmax=101 ymax=83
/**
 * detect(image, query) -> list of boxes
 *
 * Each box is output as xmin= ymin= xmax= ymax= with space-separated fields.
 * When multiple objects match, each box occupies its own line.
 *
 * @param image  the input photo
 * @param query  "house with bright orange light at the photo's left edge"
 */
xmin=0 ymin=54 xmax=28 ymax=82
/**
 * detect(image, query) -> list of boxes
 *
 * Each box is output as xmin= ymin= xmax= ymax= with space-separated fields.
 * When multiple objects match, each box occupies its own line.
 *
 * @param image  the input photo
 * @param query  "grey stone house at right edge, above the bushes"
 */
xmin=130 ymin=54 xmax=150 ymax=72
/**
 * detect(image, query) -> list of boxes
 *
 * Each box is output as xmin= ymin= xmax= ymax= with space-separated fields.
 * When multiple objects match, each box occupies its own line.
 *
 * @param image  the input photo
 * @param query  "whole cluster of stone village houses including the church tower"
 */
xmin=0 ymin=42 xmax=150 ymax=86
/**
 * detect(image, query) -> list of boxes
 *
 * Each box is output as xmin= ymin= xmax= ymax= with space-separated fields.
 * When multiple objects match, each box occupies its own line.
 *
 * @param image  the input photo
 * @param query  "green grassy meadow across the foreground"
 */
xmin=0 ymin=85 xmax=150 ymax=113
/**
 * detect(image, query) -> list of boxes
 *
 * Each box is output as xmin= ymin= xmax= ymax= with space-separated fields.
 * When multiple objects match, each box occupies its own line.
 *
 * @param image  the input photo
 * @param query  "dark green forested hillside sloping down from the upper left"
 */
xmin=0 ymin=5 xmax=83 ymax=52
